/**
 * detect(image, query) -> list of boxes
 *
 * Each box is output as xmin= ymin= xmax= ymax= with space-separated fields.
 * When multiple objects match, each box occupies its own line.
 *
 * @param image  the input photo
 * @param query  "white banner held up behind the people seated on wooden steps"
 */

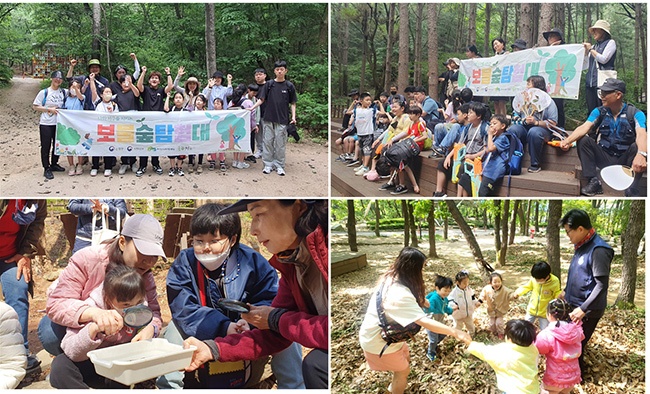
xmin=458 ymin=44 xmax=585 ymax=100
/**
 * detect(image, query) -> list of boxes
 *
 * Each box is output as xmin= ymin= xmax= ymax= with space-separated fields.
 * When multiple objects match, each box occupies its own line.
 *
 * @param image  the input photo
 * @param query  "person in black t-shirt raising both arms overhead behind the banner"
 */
xmin=135 ymin=66 xmax=174 ymax=177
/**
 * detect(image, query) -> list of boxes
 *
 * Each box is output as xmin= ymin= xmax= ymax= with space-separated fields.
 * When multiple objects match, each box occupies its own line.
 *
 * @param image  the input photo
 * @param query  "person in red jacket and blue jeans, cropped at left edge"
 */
xmin=0 ymin=200 xmax=47 ymax=373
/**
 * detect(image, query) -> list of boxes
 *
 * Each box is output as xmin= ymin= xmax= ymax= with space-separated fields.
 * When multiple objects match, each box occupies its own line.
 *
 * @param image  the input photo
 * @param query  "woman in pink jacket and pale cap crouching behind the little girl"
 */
xmin=38 ymin=214 xmax=165 ymax=355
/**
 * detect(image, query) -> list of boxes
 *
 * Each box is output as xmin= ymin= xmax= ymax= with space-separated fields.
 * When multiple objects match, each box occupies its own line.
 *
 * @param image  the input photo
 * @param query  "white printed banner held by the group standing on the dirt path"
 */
xmin=56 ymin=110 xmax=251 ymax=156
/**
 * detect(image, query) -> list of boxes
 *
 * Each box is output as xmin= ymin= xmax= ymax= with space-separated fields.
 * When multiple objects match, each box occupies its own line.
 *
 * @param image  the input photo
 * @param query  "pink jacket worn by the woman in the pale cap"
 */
xmin=46 ymin=244 xmax=162 ymax=332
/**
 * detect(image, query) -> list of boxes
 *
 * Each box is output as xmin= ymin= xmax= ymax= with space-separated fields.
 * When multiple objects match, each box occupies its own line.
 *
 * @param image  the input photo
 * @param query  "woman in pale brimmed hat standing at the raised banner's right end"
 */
xmin=582 ymin=19 xmax=616 ymax=113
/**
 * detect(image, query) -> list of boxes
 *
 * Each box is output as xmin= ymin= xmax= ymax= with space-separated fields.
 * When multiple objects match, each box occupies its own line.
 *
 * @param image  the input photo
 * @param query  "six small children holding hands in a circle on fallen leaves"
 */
xmin=424 ymin=261 xmax=584 ymax=393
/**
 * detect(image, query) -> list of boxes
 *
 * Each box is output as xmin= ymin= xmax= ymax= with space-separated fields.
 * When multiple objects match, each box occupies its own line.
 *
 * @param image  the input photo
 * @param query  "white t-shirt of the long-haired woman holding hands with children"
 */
xmin=359 ymin=282 xmax=426 ymax=354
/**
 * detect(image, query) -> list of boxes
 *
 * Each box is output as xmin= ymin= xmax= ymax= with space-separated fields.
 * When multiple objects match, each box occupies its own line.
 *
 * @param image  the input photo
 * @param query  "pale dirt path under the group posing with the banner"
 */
xmin=0 ymin=77 xmax=329 ymax=198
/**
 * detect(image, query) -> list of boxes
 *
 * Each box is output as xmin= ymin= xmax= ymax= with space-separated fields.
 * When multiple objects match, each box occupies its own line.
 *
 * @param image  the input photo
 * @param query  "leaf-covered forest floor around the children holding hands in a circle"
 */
xmin=331 ymin=230 xmax=645 ymax=394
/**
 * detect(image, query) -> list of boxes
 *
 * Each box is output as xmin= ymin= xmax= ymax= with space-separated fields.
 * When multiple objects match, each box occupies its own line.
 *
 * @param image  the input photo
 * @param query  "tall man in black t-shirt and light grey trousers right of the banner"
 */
xmin=249 ymin=60 xmax=298 ymax=176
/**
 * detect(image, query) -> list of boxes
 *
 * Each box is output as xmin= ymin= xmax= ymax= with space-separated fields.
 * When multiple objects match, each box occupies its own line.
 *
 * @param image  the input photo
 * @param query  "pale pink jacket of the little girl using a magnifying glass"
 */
xmin=61 ymin=286 xmax=134 ymax=362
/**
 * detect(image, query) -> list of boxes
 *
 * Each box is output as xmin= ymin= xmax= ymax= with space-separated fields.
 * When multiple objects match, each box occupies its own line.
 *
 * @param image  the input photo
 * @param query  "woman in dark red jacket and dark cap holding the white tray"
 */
xmin=185 ymin=200 xmax=329 ymax=389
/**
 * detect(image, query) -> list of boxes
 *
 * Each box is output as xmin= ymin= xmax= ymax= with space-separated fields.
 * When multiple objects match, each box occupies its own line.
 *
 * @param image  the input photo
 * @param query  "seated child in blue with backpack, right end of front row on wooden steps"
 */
xmin=478 ymin=114 xmax=510 ymax=197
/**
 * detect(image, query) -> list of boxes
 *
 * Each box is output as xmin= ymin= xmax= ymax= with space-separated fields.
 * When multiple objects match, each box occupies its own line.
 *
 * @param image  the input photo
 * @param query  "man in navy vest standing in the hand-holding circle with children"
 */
xmin=560 ymin=209 xmax=614 ymax=377
